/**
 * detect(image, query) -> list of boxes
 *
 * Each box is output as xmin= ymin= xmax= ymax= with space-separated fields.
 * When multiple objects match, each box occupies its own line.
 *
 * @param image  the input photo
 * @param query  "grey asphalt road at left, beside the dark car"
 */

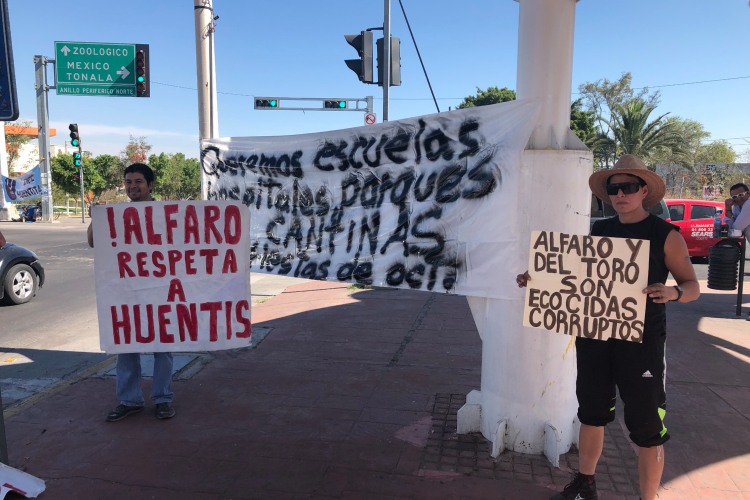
xmin=0 ymin=219 xmax=303 ymax=408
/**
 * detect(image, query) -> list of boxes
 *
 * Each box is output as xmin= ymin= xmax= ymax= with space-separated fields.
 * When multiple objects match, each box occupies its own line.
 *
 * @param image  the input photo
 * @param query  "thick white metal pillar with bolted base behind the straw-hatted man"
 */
xmin=458 ymin=0 xmax=593 ymax=466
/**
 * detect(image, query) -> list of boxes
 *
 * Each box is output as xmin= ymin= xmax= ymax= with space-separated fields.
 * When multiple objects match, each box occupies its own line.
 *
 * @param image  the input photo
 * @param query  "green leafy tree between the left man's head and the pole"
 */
xmin=148 ymin=153 xmax=200 ymax=200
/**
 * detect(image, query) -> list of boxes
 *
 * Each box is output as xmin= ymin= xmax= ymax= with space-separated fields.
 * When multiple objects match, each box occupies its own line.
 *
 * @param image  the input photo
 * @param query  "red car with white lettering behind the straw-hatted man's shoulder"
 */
xmin=665 ymin=200 xmax=724 ymax=257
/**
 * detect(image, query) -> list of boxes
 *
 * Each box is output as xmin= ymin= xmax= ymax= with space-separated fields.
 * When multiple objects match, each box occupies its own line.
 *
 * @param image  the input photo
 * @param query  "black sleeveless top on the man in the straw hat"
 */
xmin=591 ymin=214 xmax=680 ymax=340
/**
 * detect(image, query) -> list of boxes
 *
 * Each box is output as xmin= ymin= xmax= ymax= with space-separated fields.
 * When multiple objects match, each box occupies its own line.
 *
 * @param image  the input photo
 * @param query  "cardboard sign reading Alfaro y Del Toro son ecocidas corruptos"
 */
xmin=523 ymin=231 xmax=651 ymax=342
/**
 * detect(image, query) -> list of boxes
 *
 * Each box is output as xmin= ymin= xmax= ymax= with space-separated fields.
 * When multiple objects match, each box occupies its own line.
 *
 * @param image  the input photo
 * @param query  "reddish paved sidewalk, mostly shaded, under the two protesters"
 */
xmin=6 ymin=282 xmax=750 ymax=500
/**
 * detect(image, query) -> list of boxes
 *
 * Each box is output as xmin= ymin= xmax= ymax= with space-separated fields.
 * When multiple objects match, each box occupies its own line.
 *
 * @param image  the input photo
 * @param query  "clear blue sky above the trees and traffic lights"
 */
xmin=9 ymin=0 xmax=750 ymax=157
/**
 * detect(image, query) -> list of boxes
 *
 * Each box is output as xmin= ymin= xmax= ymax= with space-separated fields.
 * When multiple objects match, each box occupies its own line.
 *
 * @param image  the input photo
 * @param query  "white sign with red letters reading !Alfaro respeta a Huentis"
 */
xmin=92 ymin=201 xmax=250 ymax=353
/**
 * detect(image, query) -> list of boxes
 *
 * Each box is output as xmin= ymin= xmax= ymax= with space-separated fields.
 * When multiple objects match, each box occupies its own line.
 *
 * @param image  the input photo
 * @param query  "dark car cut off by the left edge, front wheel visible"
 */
xmin=0 ymin=243 xmax=44 ymax=305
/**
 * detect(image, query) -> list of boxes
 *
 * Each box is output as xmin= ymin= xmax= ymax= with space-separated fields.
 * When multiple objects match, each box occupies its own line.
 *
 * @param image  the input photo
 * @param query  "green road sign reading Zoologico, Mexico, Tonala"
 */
xmin=55 ymin=42 xmax=148 ymax=97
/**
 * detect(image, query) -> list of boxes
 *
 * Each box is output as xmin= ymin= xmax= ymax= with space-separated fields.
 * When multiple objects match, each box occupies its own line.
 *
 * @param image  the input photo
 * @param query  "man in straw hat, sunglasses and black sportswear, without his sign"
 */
xmin=516 ymin=155 xmax=700 ymax=500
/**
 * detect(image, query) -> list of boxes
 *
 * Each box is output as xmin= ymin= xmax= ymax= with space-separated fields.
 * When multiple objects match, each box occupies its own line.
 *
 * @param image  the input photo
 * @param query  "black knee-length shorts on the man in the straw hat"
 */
xmin=576 ymin=335 xmax=669 ymax=448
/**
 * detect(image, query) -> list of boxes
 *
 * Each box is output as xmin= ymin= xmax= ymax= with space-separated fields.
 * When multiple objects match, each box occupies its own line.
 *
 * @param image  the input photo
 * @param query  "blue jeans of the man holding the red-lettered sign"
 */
xmin=115 ymin=352 xmax=174 ymax=406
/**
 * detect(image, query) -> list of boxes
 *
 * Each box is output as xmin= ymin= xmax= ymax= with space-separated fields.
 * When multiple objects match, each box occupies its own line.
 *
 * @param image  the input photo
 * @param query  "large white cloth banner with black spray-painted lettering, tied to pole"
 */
xmin=201 ymin=101 xmax=539 ymax=298
